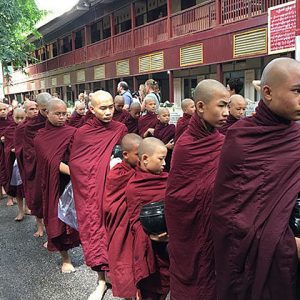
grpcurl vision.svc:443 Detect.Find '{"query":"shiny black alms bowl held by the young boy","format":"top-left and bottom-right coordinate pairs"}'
top-left (140, 201), bottom-right (167, 234)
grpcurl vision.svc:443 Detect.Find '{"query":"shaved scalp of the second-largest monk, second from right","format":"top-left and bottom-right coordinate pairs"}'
top-left (194, 79), bottom-right (227, 104)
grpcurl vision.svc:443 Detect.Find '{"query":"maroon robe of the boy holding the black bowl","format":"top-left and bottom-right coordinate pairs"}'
top-left (126, 168), bottom-right (169, 299)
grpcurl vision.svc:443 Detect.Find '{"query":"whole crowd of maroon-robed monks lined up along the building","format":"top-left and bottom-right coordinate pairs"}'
top-left (0, 58), bottom-right (300, 300)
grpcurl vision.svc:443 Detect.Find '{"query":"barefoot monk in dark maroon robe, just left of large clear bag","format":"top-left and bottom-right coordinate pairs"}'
top-left (34, 99), bottom-right (80, 273)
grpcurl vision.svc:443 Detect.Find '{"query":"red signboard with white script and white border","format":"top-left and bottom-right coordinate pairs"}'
top-left (268, 1), bottom-right (296, 54)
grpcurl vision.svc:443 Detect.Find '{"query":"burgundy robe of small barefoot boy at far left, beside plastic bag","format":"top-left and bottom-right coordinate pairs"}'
top-left (4, 122), bottom-right (24, 198)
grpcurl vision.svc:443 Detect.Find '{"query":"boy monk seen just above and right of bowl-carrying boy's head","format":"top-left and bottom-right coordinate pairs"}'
top-left (153, 107), bottom-right (175, 172)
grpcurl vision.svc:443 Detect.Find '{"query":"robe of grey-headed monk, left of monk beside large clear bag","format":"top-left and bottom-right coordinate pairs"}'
top-left (23, 113), bottom-right (46, 218)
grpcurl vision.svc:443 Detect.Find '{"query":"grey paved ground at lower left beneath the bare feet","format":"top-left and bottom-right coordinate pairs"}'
top-left (0, 199), bottom-right (122, 300)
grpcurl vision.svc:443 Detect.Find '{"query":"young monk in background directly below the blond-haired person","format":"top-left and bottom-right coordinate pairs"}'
top-left (138, 96), bottom-right (158, 138)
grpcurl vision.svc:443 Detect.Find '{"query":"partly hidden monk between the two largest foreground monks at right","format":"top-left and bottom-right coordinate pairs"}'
top-left (219, 94), bottom-right (247, 135)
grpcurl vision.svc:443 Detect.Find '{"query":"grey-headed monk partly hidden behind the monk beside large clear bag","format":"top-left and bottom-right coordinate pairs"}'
top-left (23, 93), bottom-right (52, 237)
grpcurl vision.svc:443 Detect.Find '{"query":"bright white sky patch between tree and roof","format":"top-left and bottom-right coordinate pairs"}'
top-left (35, 0), bottom-right (78, 28)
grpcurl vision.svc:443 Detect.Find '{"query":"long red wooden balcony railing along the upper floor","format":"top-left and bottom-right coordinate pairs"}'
top-left (27, 0), bottom-right (291, 75)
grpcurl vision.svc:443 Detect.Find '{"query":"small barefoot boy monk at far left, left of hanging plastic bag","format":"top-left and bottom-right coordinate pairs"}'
top-left (4, 108), bottom-right (25, 213)
